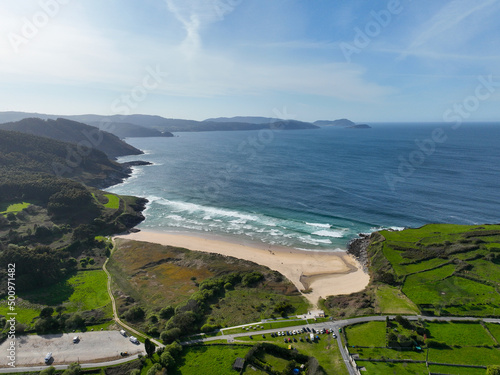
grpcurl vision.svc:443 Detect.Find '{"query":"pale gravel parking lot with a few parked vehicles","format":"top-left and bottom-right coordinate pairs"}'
top-left (0, 331), bottom-right (145, 367)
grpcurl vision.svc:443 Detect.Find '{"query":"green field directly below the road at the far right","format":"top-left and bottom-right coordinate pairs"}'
top-left (425, 322), bottom-right (496, 346)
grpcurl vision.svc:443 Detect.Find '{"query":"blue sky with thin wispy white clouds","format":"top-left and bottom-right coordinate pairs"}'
top-left (0, 0), bottom-right (500, 122)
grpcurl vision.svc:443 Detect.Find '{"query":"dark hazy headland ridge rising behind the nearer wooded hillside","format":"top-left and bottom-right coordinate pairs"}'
top-left (0, 118), bottom-right (142, 158)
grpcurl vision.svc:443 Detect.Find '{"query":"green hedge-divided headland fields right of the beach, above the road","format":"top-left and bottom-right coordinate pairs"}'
top-left (368, 224), bottom-right (500, 317)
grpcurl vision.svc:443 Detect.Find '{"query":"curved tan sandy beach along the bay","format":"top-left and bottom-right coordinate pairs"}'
top-left (117, 231), bottom-right (370, 307)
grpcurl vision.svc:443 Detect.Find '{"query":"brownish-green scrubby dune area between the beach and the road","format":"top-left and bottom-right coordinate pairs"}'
top-left (107, 240), bottom-right (307, 342)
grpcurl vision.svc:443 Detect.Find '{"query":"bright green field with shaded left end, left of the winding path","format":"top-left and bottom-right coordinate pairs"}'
top-left (20, 270), bottom-right (111, 312)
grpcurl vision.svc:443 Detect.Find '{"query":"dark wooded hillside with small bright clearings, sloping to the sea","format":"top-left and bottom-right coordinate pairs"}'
top-left (0, 130), bottom-right (146, 296)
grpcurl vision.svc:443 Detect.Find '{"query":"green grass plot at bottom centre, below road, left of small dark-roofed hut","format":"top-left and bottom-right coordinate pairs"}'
top-left (172, 345), bottom-right (250, 375)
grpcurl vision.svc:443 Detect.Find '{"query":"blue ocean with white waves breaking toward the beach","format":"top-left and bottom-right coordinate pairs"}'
top-left (107, 123), bottom-right (500, 250)
